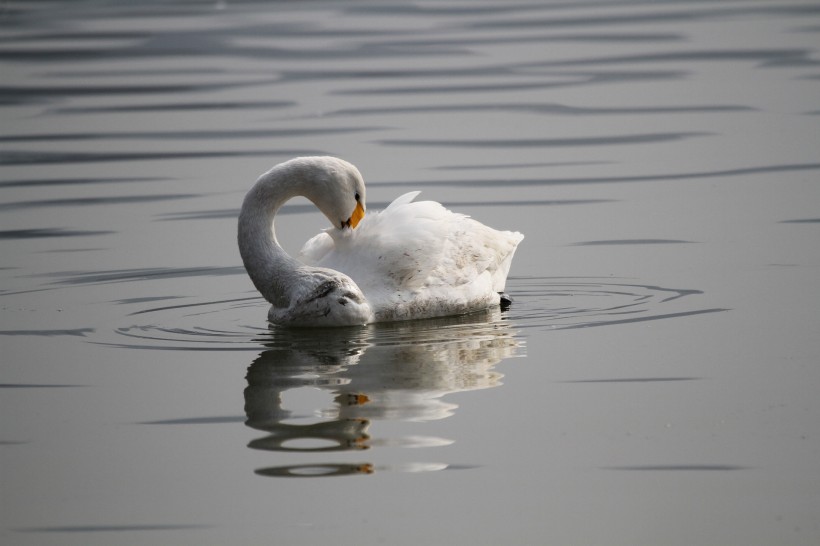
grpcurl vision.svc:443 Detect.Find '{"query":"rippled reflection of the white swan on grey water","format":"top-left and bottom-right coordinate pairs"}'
top-left (245, 310), bottom-right (520, 477)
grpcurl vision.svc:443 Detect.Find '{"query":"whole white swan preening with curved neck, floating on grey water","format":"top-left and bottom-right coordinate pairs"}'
top-left (237, 157), bottom-right (524, 326)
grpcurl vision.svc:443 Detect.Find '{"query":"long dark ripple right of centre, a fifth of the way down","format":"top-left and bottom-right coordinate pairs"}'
top-left (322, 102), bottom-right (755, 117)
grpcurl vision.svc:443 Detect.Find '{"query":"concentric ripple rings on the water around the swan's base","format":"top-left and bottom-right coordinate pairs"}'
top-left (107, 277), bottom-right (726, 351)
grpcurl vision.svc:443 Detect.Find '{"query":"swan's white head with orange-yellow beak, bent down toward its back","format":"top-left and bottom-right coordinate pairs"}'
top-left (288, 157), bottom-right (365, 229)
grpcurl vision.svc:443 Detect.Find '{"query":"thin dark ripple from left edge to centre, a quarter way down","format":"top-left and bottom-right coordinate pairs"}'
top-left (0, 127), bottom-right (384, 143)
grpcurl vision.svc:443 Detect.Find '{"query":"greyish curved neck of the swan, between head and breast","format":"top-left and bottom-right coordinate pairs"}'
top-left (238, 172), bottom-right (305, 307)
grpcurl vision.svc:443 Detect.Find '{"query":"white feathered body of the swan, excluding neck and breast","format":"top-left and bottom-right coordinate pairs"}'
top-left (300, 192), bottom-right (524, 321)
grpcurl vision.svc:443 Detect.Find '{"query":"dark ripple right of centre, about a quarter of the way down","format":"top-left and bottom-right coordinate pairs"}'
top-left (376, 133), bottom-right (712, 148)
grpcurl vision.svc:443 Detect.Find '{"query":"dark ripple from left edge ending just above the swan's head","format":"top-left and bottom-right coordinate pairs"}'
top-left (0, 149), bottom-right (327, 166)
